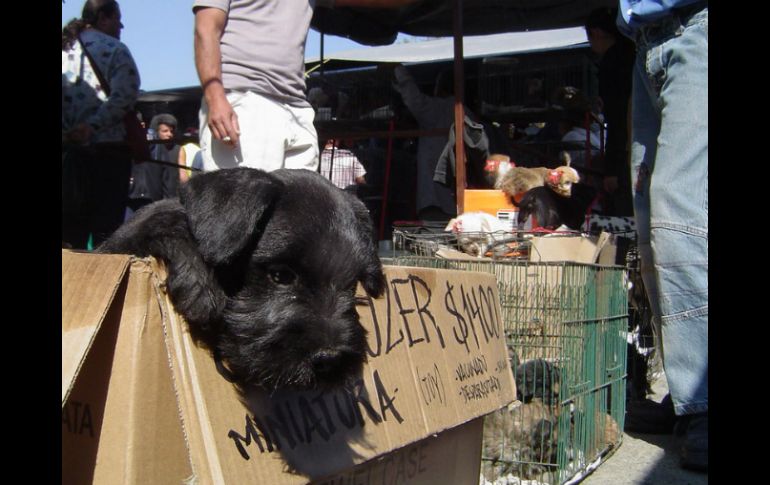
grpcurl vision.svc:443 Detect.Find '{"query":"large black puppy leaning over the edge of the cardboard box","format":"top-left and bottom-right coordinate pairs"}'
top-left (97, 168), bottom-right (385, 389)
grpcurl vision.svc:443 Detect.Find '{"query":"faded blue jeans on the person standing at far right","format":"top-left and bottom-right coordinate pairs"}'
top-left (631, 8), bottom-right (708, 415)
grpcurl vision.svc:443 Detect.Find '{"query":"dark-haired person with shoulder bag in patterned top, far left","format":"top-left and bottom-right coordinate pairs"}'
top-left (62, 0), bottom-right (142, 249)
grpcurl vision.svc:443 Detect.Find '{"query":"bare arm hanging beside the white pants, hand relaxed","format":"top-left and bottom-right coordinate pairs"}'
top-left (195, 7), bottom-right (240, 146)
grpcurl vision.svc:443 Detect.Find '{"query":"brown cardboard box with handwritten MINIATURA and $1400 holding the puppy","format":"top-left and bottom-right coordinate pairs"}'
top-left (62, 251), bottom-right (516, 484)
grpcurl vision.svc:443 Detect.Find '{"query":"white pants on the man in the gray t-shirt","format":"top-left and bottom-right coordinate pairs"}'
top-left (200, 91), bottom-right (318, 172)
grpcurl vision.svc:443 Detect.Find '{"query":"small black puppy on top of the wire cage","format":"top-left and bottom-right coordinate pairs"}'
top-left (512, 184), bottom-right (596, 230)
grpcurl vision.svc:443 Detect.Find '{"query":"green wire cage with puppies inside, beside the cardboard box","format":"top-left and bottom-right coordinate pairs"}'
top-left (389, 229), bottom-right (628, 485)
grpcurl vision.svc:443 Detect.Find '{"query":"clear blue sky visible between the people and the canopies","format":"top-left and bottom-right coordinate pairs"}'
top-left (62, 0), bottom-right (402, 91)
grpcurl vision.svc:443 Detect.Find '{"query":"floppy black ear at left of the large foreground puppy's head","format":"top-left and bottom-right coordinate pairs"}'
top-left (179, 168), bottom-right (283, 265)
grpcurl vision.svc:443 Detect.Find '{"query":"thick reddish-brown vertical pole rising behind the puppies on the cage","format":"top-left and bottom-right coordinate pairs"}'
top-left (452, 0), bottom-right (465, 215)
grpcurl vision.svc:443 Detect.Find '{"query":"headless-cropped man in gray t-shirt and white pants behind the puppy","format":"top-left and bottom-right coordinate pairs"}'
top-left (193, 0), bottom-right (415, 171)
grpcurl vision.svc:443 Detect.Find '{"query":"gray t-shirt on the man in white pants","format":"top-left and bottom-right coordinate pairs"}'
top-left (193, 0), bottom-right (330, 107)
